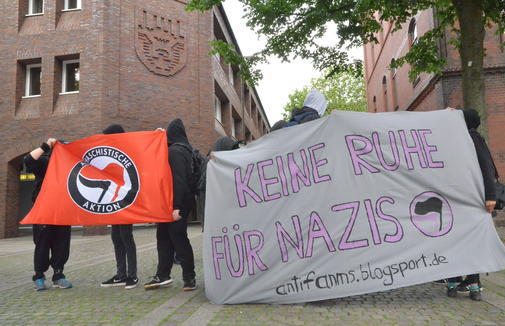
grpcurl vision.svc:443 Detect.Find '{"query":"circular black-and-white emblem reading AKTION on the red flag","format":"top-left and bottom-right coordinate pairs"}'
top-left (67, 146), bottom-right (140, 214)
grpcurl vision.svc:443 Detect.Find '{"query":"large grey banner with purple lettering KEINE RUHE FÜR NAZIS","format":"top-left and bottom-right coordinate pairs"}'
top-left (204, 110), bottom-right (505, 304)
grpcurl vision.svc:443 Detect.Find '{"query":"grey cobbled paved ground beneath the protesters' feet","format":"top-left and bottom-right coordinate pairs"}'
top-left (0, 226), bottom-right (505, 326)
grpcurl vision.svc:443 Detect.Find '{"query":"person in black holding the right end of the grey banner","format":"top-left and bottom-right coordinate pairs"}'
top-left (447, 109), bottom-right (498, 301)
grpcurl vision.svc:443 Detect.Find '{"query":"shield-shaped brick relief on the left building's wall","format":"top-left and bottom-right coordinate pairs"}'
top-left (135, 8), bottom-right (187, 76)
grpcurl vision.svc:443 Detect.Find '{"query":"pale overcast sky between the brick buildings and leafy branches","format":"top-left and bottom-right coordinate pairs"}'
top-left (223, 0), bottom-right (363, 125)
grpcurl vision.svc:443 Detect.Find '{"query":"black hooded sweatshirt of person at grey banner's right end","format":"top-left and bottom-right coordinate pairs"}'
top-left (463, 109), bottom-right (498, 201)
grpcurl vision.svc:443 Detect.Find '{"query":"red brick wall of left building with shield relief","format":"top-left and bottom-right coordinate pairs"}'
top-left (0, 0), bottom-right (272, 238)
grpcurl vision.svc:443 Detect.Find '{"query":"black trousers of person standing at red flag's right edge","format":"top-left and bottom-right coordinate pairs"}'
top-left (156, 216), bottom-right (196, 280)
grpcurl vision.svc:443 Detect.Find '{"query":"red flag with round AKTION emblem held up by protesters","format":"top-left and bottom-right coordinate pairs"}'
top-left (21, 131), bottom-right (173, 225)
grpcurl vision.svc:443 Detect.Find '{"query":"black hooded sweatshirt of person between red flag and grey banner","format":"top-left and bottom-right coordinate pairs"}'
top-left (167, 119), bottom-right (194, 217)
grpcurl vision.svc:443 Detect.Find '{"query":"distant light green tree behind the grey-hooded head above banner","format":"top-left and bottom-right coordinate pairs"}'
top-left (283, 71), bottom-right (366, 120)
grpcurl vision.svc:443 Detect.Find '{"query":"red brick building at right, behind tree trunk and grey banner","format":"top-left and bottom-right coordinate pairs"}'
top-left (364, 9), bottom-right (505, 199)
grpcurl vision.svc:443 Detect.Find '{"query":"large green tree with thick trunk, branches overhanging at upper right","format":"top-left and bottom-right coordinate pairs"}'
top-left (187, 0), bottom-right (505, 132)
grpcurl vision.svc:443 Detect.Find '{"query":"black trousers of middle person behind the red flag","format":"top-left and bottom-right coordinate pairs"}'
top-left (111, 224), bottom-right (137, 279)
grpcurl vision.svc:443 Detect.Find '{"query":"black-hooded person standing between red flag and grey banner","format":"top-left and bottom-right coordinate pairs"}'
top-left (144, 119), bottom-right (196, 291)
